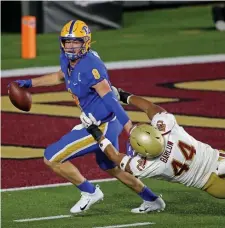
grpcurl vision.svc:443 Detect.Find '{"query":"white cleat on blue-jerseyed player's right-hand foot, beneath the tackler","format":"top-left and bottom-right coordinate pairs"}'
top-left (131, 196), bottom-right (166, 213)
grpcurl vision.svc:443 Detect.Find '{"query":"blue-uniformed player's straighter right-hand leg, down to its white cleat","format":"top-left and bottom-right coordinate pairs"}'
top-left (96, 120), bottom-right (166, 213)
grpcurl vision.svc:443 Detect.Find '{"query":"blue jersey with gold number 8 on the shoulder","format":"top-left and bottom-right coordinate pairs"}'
top-left (60, 51), bottom-right (112, 120)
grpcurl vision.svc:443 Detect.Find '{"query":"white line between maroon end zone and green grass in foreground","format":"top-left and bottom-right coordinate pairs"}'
top-left (1, 178), bottom-right (117, 192)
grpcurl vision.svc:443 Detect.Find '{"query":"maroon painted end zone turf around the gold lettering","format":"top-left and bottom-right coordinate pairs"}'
top-left (2, 62), bottom-right (225, 188)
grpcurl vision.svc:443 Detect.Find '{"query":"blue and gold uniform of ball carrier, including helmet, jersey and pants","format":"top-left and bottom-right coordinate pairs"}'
top-left (44, 21), bottom-right (129, 170)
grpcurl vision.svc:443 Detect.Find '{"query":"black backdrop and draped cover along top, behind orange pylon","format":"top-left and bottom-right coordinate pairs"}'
top-left (1, 1), bottom-right (212, 33)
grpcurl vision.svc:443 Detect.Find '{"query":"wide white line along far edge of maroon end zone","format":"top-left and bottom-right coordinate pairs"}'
top-left (1, 54), bottom-right (225, 77)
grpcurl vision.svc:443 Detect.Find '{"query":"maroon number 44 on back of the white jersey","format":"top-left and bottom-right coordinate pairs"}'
top-left (171, 141), bottom-right (196, 176)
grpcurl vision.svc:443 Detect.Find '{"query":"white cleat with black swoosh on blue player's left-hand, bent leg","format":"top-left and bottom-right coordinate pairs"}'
top-left (70, 185), bottom-right (104, 214)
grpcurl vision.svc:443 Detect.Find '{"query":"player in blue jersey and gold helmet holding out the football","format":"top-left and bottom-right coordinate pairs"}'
top-left (9, 20), bottom-right (165, 213)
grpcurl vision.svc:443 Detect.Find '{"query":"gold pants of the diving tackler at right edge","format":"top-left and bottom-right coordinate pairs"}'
top-left (203, 173), bottom-right (225, 199)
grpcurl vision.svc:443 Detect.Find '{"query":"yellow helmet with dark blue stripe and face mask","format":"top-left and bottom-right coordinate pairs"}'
top-left (60, 20), bottom-right (91, 60)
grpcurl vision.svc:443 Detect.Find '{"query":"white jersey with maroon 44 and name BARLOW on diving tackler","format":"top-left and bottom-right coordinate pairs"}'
top-left (130, 112), bottom-right (219, 188)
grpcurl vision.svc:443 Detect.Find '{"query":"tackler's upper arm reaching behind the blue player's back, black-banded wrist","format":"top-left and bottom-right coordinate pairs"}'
top-left (113, 87), bottom-right (166, 120)
